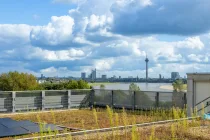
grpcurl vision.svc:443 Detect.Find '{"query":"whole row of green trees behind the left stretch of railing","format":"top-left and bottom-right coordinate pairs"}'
top-left (0, 71), bottom-right (91, 91)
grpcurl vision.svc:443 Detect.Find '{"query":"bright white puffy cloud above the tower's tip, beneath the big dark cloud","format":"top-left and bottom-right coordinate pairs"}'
top-left (136, 36), bottom-right (205, 63)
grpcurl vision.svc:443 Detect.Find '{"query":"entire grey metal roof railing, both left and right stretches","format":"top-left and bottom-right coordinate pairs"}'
top-left (0, 90), bottom-right (186, 112)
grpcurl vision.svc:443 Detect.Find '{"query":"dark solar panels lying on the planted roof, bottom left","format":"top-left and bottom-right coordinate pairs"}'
top-left (0, 118), bottom-right (63, 137)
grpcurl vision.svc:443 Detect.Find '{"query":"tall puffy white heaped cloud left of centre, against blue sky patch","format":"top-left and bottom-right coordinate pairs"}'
top-left (30, 16), bottom-right (74, 45)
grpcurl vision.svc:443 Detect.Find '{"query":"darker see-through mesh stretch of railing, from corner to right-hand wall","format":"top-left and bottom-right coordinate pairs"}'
top-left (92, 90), bottom-right (187, 109)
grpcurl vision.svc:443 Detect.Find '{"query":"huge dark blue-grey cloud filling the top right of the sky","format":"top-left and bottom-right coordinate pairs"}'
top-left (111, 0), bottom-right (210, 35)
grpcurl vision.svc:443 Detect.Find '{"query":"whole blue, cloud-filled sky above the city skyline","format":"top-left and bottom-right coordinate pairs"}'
top-left (0, 0), bottom-right (210, 78)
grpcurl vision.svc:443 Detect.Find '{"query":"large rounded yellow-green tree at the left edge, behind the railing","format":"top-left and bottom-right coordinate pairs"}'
top-left (0, 71), bottom-right (39, 91)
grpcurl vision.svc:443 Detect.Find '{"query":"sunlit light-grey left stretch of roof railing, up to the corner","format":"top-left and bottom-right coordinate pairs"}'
top-left (0, 90), bottom-right (92, 112)
